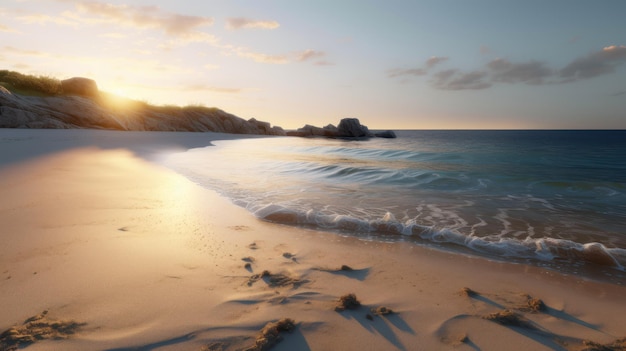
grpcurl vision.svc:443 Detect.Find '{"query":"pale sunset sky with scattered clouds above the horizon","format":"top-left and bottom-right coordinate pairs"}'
top-left (0, 0), bottom-right (626, 129)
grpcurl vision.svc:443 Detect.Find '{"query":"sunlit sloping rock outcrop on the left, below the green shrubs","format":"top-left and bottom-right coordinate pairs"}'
top-left (0, 88), bottom-right (285, 135)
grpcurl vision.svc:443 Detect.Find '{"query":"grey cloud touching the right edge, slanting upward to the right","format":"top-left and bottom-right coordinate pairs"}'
top-left (560, 45), bottom-right (626, 82)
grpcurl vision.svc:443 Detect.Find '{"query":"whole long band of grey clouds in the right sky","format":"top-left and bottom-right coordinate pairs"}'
top-left (387, 45), bottom-right (626, 90)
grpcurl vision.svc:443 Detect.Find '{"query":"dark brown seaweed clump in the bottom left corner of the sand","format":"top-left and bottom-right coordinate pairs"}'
top-left (0, 311), bottom-right (86, 351)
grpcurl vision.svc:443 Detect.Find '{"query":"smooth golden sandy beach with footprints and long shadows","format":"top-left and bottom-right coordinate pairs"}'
top-left (0, 130), bottom-right (626, 351)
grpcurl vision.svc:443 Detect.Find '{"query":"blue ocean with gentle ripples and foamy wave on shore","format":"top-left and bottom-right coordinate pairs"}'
top-left (163, 130), bottom-right (626, 285)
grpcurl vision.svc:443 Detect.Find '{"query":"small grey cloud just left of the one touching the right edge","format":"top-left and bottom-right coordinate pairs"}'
top-left (487, 58), bottom-right (554, 85)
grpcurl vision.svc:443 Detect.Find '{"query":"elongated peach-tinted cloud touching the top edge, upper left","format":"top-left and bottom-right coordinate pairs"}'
top-left (76, 1), bottom-right (214, 36)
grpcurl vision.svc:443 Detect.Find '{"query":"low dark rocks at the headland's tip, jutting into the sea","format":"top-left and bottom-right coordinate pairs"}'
top-left (287, 118), bottom-right (396, 139)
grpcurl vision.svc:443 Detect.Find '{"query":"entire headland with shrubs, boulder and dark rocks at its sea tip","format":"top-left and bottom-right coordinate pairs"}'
top-left (0, 70), bottom-right (396, 139)
